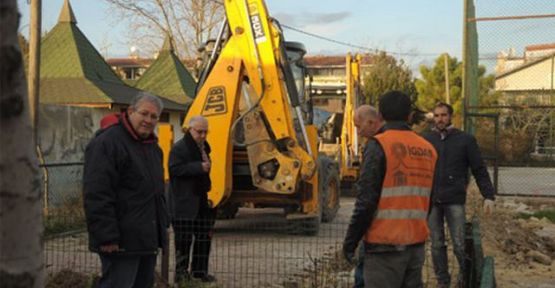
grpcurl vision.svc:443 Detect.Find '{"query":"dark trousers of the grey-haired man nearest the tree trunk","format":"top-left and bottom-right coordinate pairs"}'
top-left (98, 254), bottom-right (156, 288)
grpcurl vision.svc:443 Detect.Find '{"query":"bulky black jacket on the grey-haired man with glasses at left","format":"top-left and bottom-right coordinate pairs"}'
top-left (83, 115), bottom-right (169, 253)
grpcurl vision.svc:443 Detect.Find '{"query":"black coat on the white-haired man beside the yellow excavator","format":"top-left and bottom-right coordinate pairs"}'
top-left (169, 132), bottom-right (211, 219)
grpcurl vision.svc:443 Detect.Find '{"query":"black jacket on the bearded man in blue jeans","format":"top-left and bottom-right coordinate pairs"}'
top-left (424, 128), bottom-right (495, 204)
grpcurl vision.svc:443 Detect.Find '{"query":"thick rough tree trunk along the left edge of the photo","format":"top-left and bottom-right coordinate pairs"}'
top-left (0, 0), bottom-right (44, 287)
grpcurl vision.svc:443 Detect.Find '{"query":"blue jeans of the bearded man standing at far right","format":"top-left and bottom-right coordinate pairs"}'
top-left (428, 204), bottom-right (466, 285)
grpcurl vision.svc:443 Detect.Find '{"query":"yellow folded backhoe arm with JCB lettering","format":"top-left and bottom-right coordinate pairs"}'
top-left (184, 0), bottom-right (316, 206)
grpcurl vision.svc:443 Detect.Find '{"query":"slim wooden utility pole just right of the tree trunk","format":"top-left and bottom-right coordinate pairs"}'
top-left (27, 0), bottom-right (42, 146)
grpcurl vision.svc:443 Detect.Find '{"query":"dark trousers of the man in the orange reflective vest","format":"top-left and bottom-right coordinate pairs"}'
top-left (364, 244), bottom-right (424, 288)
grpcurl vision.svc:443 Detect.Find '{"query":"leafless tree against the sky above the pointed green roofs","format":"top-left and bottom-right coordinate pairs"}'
top-left (105, 0), bottom-right (224, 58)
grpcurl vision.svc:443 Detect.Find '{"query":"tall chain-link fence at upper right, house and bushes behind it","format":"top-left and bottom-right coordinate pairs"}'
top-left (464, 0), bottom-right (555, 197)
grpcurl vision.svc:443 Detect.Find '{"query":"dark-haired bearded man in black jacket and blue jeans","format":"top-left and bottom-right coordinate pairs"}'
top-left (424, 102), bottom-right (495, 287)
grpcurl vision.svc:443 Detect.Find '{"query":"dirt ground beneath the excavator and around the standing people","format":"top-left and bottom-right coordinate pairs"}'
top-left (45, 190), bottom-right (555, 288)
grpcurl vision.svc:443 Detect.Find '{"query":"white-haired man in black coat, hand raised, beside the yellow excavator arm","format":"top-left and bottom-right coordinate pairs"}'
top-left (169, 116), bottom-right (216, 282)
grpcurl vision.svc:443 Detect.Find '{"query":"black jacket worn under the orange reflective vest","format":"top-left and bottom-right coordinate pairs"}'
top-left (343, 122), bottom-right (411, 254)
